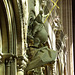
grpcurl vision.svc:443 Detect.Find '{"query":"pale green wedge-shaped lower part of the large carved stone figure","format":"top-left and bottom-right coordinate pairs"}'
top-left (26, 46), bottom-right (58, 70)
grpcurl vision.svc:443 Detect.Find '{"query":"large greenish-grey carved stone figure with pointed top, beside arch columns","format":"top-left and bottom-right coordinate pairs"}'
top-left (26, 11), bottom-right (57, 70)
